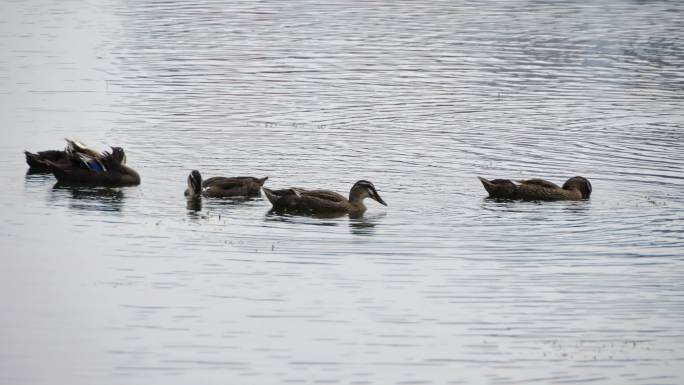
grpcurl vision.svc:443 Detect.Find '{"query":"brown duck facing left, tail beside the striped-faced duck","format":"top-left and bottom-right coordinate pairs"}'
top-left (185, 170), bottom-right (268, 198)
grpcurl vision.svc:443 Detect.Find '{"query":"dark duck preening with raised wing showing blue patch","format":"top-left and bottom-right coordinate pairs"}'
top-left (45, 147), bottom-right (140, 187)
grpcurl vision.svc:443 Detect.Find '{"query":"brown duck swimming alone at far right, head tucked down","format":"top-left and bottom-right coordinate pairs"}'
top-left (478, 176), bottom-right (591, 201)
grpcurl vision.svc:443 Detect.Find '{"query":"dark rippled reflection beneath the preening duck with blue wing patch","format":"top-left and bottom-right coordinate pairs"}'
top-left (49, 183), bottom-right (126, 212)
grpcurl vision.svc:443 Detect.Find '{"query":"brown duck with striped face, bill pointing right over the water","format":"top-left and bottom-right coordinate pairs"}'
top-left (263, 180), bottom-right (387, 215)
